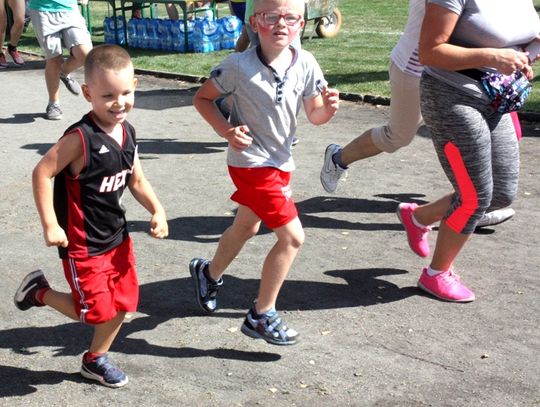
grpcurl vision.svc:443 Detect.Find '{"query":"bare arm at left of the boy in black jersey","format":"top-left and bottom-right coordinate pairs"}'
top-left (32, 133), bottom-right (83, 247)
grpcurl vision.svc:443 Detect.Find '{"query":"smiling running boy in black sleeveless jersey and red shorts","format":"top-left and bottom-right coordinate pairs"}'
top-left (14, 45), bottom-right (168, 387)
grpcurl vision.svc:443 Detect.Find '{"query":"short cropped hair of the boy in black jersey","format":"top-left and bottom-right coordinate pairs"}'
top-left (84, 44), bottom-right (133, 82)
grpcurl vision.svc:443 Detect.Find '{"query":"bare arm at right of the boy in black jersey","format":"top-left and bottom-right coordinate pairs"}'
top-left (129, 156), bottom-right (169, 239)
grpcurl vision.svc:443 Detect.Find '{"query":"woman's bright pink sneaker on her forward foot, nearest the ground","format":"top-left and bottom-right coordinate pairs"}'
top-left (418, 267), bottom-right (475, 302)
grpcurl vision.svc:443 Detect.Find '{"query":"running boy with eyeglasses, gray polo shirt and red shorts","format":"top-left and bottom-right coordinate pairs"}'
top-left (189, 0), bottom-right (339, 345)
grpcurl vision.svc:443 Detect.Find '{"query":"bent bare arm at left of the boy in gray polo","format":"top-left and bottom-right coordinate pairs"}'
top-left (193, 80), bottom-right (253, 151)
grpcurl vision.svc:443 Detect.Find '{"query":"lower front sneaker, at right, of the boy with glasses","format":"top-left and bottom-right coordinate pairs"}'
top-left (240, 307), bottom-right (300, 345)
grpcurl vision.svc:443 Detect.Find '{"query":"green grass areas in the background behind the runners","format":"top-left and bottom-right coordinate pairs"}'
top-left (20, 0), bottom-right (540, 112)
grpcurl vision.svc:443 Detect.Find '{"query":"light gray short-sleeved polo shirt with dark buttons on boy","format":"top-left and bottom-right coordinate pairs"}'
top-left (211, 47), bottom-right (325, 172)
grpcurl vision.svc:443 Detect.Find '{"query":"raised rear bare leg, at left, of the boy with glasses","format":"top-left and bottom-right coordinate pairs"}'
top-left (208, 205), bottom-right (261, 281)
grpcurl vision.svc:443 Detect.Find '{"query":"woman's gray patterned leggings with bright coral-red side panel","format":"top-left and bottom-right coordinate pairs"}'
top-left (420, 73), bottom-right (519, 234)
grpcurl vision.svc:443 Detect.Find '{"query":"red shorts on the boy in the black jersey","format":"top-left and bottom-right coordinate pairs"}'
top-left (62, 237), bottom-right (139, 325)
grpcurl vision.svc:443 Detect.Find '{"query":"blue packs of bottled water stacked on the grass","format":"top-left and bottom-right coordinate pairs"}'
top-left (122, 16), bottom-right (242, 53)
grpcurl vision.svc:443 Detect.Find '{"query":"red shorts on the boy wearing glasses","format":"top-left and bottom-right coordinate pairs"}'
top-left (229, 166), bottom-right (298, 229)
